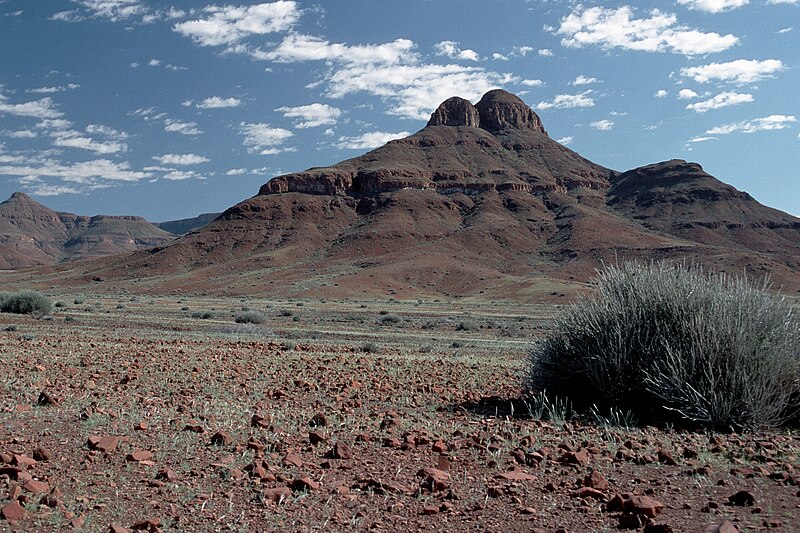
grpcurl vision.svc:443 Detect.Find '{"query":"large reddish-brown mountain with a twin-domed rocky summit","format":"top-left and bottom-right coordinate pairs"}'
top-left (7, 90), bottom-right (800, 299)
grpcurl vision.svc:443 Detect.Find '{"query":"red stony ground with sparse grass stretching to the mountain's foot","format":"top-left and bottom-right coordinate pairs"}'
top-left (0, 293), bottom-right (800, 533)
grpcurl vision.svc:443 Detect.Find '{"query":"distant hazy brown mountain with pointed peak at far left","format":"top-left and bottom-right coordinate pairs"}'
top-left (0, 192), bottom-right (175, 269)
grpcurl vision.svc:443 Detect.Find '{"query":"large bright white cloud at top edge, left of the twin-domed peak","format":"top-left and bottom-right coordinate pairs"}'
top-left (173, 0), bottom-right (300, 46)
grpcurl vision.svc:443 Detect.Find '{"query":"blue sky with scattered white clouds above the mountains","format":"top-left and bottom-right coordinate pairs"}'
top-left (0, 0), bottom-right (800, 221)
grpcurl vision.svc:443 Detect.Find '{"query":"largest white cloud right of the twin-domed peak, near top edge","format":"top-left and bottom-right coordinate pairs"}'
top-left (555, 5), bottom-right (739, 56)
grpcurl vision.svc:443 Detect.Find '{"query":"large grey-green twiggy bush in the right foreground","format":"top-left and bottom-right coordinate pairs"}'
top-left (525, 263), bottom-right (800, 430)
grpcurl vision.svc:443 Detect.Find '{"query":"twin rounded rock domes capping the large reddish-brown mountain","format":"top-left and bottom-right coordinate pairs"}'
top-left (428, 89), bottom-right (547, 134)
